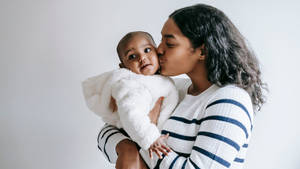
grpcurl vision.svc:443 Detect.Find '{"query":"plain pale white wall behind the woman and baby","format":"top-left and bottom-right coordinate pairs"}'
top-left (0, 0), bottom-right (300, 169)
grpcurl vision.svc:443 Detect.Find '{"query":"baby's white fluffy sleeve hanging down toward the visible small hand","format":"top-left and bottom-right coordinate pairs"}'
top-left (112, 79), bottom-right (160, 150)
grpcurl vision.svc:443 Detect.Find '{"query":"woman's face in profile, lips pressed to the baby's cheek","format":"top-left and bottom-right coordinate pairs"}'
top-left (157, 18), bottom-right (198, 76)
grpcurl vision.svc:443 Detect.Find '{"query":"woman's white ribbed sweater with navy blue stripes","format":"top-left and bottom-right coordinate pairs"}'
top-left (98, 79), bottom-right (253, 169)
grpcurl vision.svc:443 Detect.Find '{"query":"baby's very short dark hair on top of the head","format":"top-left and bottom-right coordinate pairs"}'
top-left (117, 31), bottom-right (156, 63)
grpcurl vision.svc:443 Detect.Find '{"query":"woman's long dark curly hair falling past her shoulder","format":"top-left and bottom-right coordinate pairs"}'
top-left (169, 4), bottom-right (267, 110)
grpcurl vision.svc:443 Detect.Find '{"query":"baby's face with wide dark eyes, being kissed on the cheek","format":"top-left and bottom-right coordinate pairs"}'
top-left (120, 34), bottom-right (159, 75)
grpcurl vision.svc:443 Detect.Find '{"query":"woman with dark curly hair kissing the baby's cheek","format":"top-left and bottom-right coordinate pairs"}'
top-left (98, 4), bottom-right (264, 168)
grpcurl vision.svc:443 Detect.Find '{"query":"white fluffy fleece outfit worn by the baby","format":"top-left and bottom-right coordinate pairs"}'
top-left (82, 68), bottom-right (178, 150)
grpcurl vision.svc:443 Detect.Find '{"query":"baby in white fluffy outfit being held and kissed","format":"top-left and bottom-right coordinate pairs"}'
top-left (82, 31), bottom-right (178, 158)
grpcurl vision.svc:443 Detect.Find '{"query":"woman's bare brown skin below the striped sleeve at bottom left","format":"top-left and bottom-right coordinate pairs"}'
top-left (116, 139), bottom-right (148, 169)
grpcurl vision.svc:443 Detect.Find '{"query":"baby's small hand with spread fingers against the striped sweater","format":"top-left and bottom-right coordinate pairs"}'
top-left (149, 134), bottom-right (171, 159)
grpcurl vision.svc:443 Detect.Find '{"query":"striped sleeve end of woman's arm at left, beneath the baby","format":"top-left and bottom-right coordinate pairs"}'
top-left (97, 124), bottom-right (130, 163)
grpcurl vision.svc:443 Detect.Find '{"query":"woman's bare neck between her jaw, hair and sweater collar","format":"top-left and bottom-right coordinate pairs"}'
top-left (187, 62), bottom-right (212, 96)
